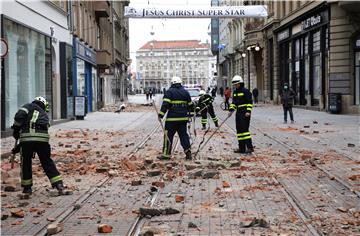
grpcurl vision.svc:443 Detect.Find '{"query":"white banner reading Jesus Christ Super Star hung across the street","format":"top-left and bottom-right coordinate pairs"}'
top-left (124, 5), bottom-right (268, 18)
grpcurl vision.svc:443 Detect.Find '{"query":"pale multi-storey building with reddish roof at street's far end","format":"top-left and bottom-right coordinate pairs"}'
top-left (136, 40), bottom-right (215, 91)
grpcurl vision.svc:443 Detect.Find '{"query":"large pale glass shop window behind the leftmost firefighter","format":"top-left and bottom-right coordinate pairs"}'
top-left (1, 15), bottom-right (53, 131)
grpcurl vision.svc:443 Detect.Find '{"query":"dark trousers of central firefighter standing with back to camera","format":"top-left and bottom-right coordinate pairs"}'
top-left (163, 121), bottom-right (190, 157)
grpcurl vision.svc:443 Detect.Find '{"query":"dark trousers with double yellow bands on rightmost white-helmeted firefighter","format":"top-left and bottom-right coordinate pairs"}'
top-left (235, 111), bottom-right (253, 152)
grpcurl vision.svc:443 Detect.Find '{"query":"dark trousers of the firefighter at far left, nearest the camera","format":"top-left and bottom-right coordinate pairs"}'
top-left (21, 142), bottom-right (62, 187)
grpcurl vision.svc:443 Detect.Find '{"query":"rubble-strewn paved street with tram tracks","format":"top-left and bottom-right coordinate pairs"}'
top-left (1, 94), bottom-right (360, 235)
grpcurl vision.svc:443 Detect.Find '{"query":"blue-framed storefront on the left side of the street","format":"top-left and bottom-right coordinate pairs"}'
top-left (73, 38), bottom-right (98, 112)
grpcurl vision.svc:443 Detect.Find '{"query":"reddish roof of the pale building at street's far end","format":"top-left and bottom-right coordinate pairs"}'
top-left (139, 40), bottom-right (210, 50)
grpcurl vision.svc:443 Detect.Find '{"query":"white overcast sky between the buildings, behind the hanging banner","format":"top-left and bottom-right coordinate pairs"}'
top-left (129, 0), bottom-right (211, 71)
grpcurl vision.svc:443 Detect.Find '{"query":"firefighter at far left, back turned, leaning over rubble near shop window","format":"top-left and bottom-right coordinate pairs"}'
top-left (12, 97), bottom-right (64, 194)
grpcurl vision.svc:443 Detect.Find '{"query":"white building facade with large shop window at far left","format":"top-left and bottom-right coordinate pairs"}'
top-left (0, 1), bottom-right (73, 134)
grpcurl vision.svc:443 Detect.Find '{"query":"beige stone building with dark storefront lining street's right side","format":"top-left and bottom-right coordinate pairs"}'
top-left (227, 1), bottom-right (360, 113)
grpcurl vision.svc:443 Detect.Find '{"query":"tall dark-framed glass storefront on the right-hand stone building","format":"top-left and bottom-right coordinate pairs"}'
top-left (276, 9), bottom-right (329, 109)
